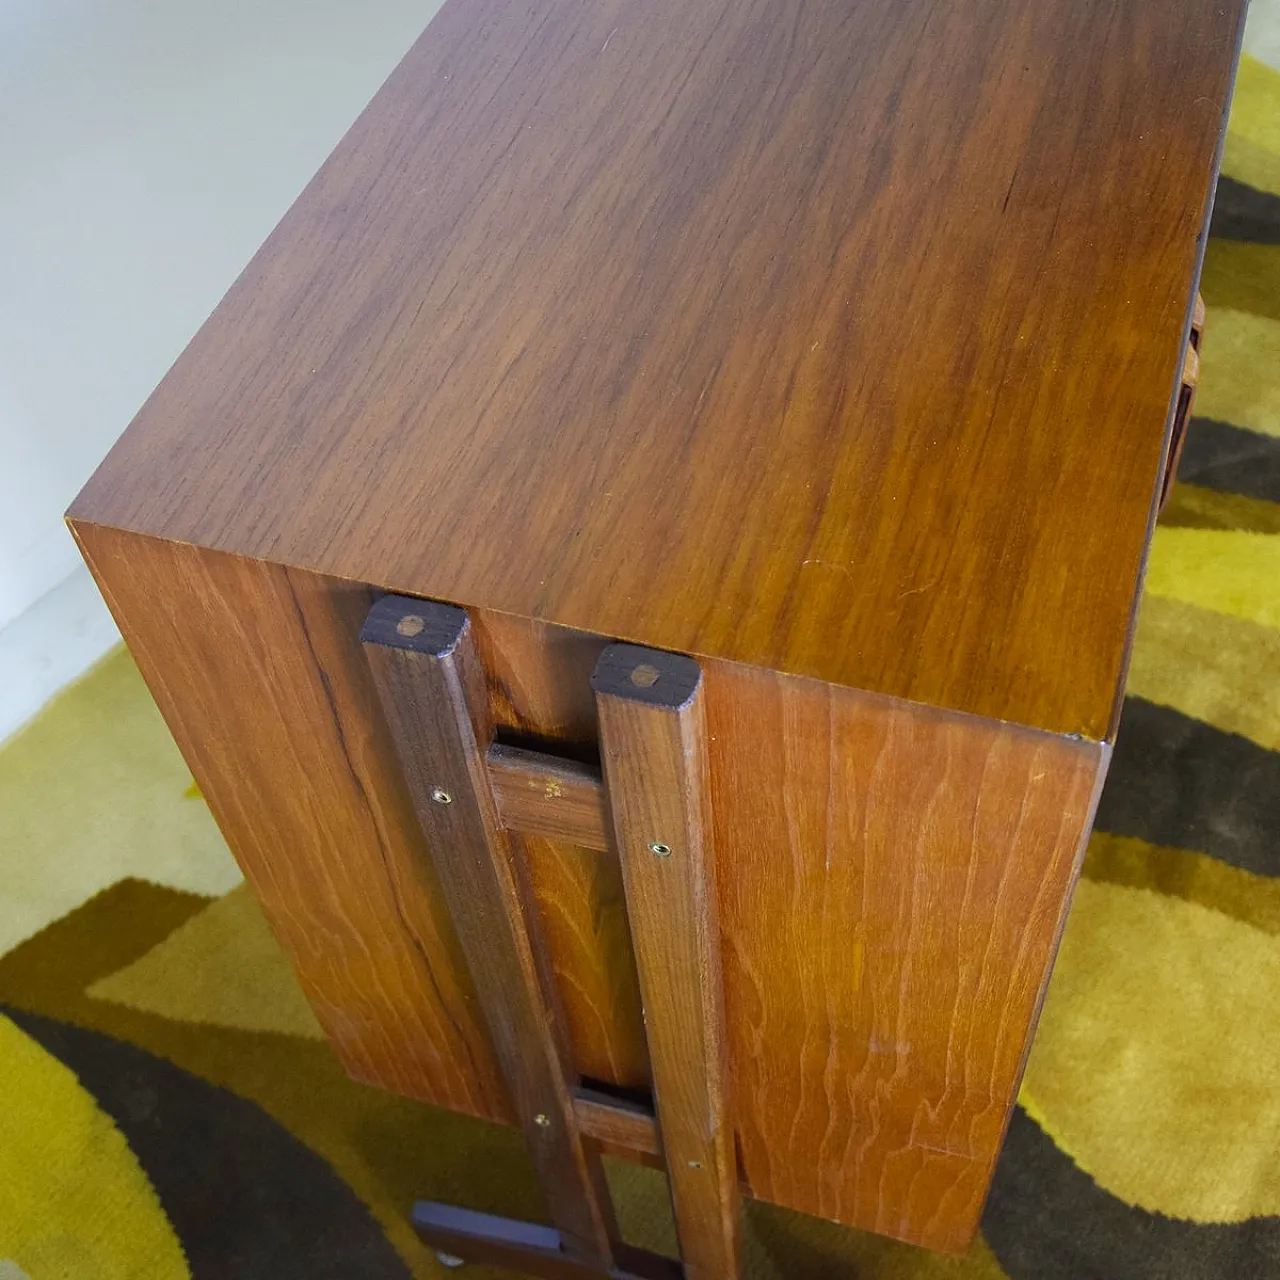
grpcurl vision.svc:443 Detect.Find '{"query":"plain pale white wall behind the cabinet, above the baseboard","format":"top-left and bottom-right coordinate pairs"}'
top-left (0, 0), bottom-right (438, 629)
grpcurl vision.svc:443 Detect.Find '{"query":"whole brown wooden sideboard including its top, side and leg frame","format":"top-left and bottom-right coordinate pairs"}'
top-left (69, 0), bottom-right (1243, 1277)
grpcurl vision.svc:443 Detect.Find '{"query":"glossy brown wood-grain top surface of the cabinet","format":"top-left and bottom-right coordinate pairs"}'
top-left (72, 0), bottom-right (1243, 737)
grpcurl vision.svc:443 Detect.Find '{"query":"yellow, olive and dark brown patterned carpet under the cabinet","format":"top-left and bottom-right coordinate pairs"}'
top-left (0, 49), bottom-right (1280, 1280)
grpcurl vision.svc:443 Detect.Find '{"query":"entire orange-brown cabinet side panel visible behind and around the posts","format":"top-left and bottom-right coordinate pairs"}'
top-left (77, 526), bottom-right (1106, 1248)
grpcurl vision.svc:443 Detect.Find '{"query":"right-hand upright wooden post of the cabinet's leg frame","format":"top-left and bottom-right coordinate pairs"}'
top-left (591, 644), bottom-right (741, 1280)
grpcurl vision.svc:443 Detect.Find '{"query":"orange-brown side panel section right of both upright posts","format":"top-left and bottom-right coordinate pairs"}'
top-left (707, 663), bottom-right (1103, 1249)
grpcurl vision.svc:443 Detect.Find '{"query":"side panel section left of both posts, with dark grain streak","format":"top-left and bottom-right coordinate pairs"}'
top-left (74, 524), bottom-right (511, 1120)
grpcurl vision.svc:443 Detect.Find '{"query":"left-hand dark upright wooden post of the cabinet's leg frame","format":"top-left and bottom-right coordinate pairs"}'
top-left (361, 595), bottom-right (620, 1271)
